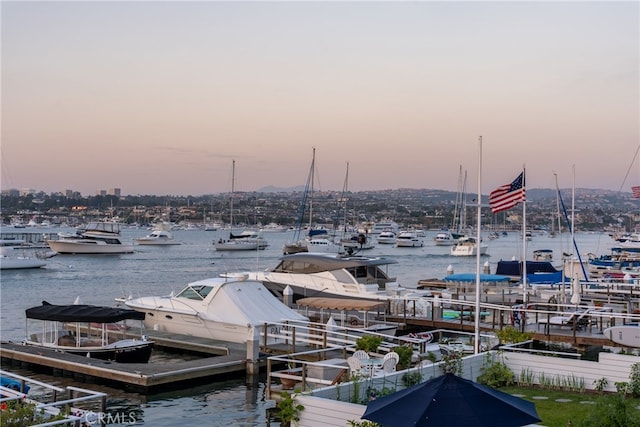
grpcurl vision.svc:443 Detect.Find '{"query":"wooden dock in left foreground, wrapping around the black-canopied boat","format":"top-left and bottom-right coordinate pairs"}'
top-left (0, 331), bottom-right (255, 393)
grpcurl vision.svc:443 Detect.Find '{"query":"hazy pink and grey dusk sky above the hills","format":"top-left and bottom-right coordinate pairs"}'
top-left (0, 1), bottom-right (640, 196)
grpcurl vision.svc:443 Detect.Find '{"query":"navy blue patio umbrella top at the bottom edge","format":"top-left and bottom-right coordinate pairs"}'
top-left (362, 374), bottom-right (541, 427)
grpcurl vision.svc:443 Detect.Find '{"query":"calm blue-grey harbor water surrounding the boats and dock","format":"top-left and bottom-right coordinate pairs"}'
top-left (0, 229), bottom-right (613, 427)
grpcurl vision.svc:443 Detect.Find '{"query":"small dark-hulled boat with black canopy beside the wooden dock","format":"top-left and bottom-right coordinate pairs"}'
top-left (24, 301), bottom-right (154, 363)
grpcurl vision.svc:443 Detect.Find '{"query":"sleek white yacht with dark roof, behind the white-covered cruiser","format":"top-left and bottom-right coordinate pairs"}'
top-left (248, 252), bottom-right (426, 300)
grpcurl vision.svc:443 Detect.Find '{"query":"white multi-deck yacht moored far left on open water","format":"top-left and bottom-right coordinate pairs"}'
top-left (46, 221), bottom-right (133, 254)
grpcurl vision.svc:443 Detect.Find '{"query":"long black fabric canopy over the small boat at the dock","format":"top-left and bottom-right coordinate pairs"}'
top-left (26, 301), bottom-right (144, 323)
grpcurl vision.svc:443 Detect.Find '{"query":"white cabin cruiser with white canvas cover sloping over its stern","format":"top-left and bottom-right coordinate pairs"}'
top-left (120, 274), bottom-right (307, 343)
